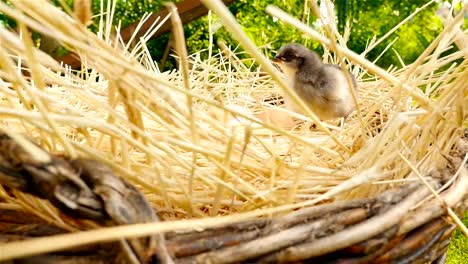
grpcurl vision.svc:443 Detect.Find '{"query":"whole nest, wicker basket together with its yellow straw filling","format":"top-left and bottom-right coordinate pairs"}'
top-left (0, 0), bottom-right (468, 263)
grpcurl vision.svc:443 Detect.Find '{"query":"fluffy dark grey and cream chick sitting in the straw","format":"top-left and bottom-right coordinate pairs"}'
top-left (272, 43), bottom-right (356, 120)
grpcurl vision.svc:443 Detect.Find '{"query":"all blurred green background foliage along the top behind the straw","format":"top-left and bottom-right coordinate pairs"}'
top-left (0, 0), bottom-right (467, 68)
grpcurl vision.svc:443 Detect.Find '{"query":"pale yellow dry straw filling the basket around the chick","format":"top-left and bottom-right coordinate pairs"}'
top-left (0, 0), bottom-right (468, 260)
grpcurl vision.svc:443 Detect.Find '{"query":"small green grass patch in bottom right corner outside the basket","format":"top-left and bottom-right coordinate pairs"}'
top-left (446, 212), bottom-right (468, 264)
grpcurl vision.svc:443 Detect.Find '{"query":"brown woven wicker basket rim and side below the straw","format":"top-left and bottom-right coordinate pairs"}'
top-left (0, 131), bottom-right (468, 263)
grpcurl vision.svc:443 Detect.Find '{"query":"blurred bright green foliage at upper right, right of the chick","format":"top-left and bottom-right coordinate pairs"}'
top-left (348, 0), bottom-right (443, 67)
